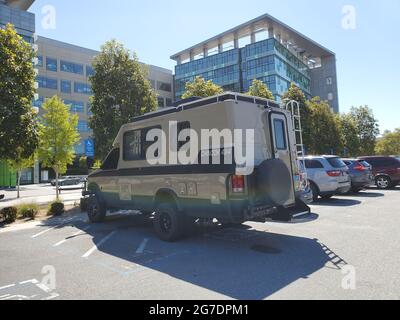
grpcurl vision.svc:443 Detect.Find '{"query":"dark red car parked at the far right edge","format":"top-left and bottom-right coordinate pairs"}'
top-left (359, 157), bottom-right (400, 190)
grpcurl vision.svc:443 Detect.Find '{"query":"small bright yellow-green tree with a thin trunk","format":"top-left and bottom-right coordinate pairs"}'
top-left (38, 96), bottom-right (80, 200)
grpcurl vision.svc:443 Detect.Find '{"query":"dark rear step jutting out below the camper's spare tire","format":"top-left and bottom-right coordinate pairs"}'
top-left (268, 199), bottom-right (314, 223)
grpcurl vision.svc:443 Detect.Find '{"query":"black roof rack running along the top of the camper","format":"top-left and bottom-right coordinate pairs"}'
top-left (133, 92), bottom-right (281, 122)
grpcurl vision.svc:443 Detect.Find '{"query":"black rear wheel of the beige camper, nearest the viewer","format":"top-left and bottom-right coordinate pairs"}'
top-left (154, 203), bottom-right (185, 242)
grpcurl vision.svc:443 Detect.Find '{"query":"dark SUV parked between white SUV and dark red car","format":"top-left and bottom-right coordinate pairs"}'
top-left (343, 159), bottom-right (375, 192)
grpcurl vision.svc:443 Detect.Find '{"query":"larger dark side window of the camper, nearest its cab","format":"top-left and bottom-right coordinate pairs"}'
top-left (124, 126), bottom-right (161, 161)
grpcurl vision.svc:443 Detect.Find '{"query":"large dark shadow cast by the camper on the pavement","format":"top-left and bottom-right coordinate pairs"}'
top-left (61, 212), bottom-right (338, 300)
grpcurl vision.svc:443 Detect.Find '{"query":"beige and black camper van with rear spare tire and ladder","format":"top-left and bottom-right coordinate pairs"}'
top-left (84, 93), bottom-right (310, 241)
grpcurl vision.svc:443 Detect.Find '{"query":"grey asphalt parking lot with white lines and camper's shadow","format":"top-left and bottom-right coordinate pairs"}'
top-left (0, 188), bottom-right (400, 300)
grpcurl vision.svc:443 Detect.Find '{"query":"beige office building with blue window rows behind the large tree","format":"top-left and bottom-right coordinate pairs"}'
top-left (34, 37), bottom-right (174, 156)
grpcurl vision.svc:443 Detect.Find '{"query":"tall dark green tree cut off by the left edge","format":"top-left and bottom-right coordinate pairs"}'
top-left (0, 24), bottom-right (38, 163)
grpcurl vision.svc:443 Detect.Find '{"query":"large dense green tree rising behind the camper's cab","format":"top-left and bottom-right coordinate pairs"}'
top-left (90, 40), bottom-right (157, 158)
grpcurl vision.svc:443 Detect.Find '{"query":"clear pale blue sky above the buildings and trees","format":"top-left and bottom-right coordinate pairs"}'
top-left (30, 0), bottom-right (400, 131)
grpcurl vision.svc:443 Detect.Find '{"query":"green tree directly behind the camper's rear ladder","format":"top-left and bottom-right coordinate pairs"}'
top-left (282, 83), bottom-right (312, 150)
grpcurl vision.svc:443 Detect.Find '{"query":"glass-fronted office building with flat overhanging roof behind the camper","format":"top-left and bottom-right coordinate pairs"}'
top-left (171, 14), bottom-right (339, 112)
